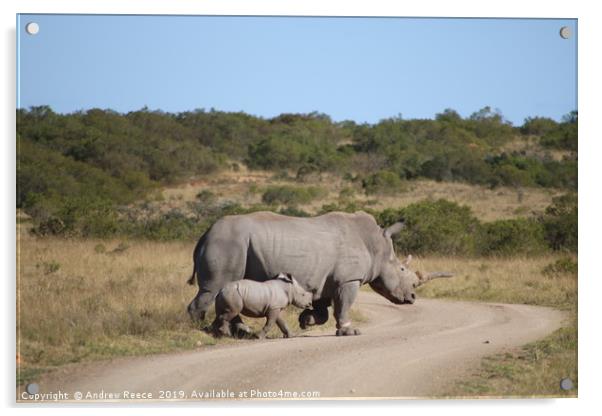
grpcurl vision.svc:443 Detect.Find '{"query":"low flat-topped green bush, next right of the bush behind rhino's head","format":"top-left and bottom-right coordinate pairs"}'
top-left (478, 218), bottom-right (548, 256)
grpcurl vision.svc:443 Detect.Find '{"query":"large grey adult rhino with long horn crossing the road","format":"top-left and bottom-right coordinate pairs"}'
top-left (188, 212), bottom-right (450, 335)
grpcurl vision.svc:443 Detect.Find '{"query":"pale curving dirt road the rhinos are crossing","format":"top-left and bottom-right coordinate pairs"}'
top-left (25, 292), bottom-right (563, 400)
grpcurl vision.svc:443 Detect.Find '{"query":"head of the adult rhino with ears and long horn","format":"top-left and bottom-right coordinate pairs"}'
top-left (369, 222), bottom-right (453, 305)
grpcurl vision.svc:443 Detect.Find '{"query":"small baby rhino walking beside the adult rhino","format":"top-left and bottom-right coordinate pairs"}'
top-left (211, 273), bottom-right (312, 338)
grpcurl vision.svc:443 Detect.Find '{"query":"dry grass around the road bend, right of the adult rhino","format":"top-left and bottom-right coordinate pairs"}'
top-left (414, 255), bottom-right (577, 397)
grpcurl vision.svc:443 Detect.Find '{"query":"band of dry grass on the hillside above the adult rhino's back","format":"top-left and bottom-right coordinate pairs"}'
top-left (160, 162), bottom-right (562, 221)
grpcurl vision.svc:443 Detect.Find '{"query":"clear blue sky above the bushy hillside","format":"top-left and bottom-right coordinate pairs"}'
top-left (17, 15), bottom-right (577, 125)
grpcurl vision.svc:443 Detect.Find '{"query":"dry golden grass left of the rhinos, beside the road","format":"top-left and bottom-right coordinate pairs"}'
top-left (17, 230), bottom-right (356, 383)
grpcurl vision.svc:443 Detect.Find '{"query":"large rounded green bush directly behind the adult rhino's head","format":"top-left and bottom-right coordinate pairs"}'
top-left (377, 199), bottom-right (479, 255)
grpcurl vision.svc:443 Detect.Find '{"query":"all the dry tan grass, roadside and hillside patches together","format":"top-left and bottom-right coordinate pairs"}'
top-left (17, 170), bottom-right (577, 396)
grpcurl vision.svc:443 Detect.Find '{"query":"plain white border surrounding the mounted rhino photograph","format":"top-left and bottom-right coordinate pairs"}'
top-left (0, 0), bottom-right (602, 416)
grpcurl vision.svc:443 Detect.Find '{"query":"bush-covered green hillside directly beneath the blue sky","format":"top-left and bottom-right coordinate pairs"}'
top-left (17, 107), bottom-right (577, 238)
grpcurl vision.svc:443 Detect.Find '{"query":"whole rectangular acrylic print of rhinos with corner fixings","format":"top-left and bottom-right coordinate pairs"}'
top-left (17, 15), bottom-right (578, 403)
